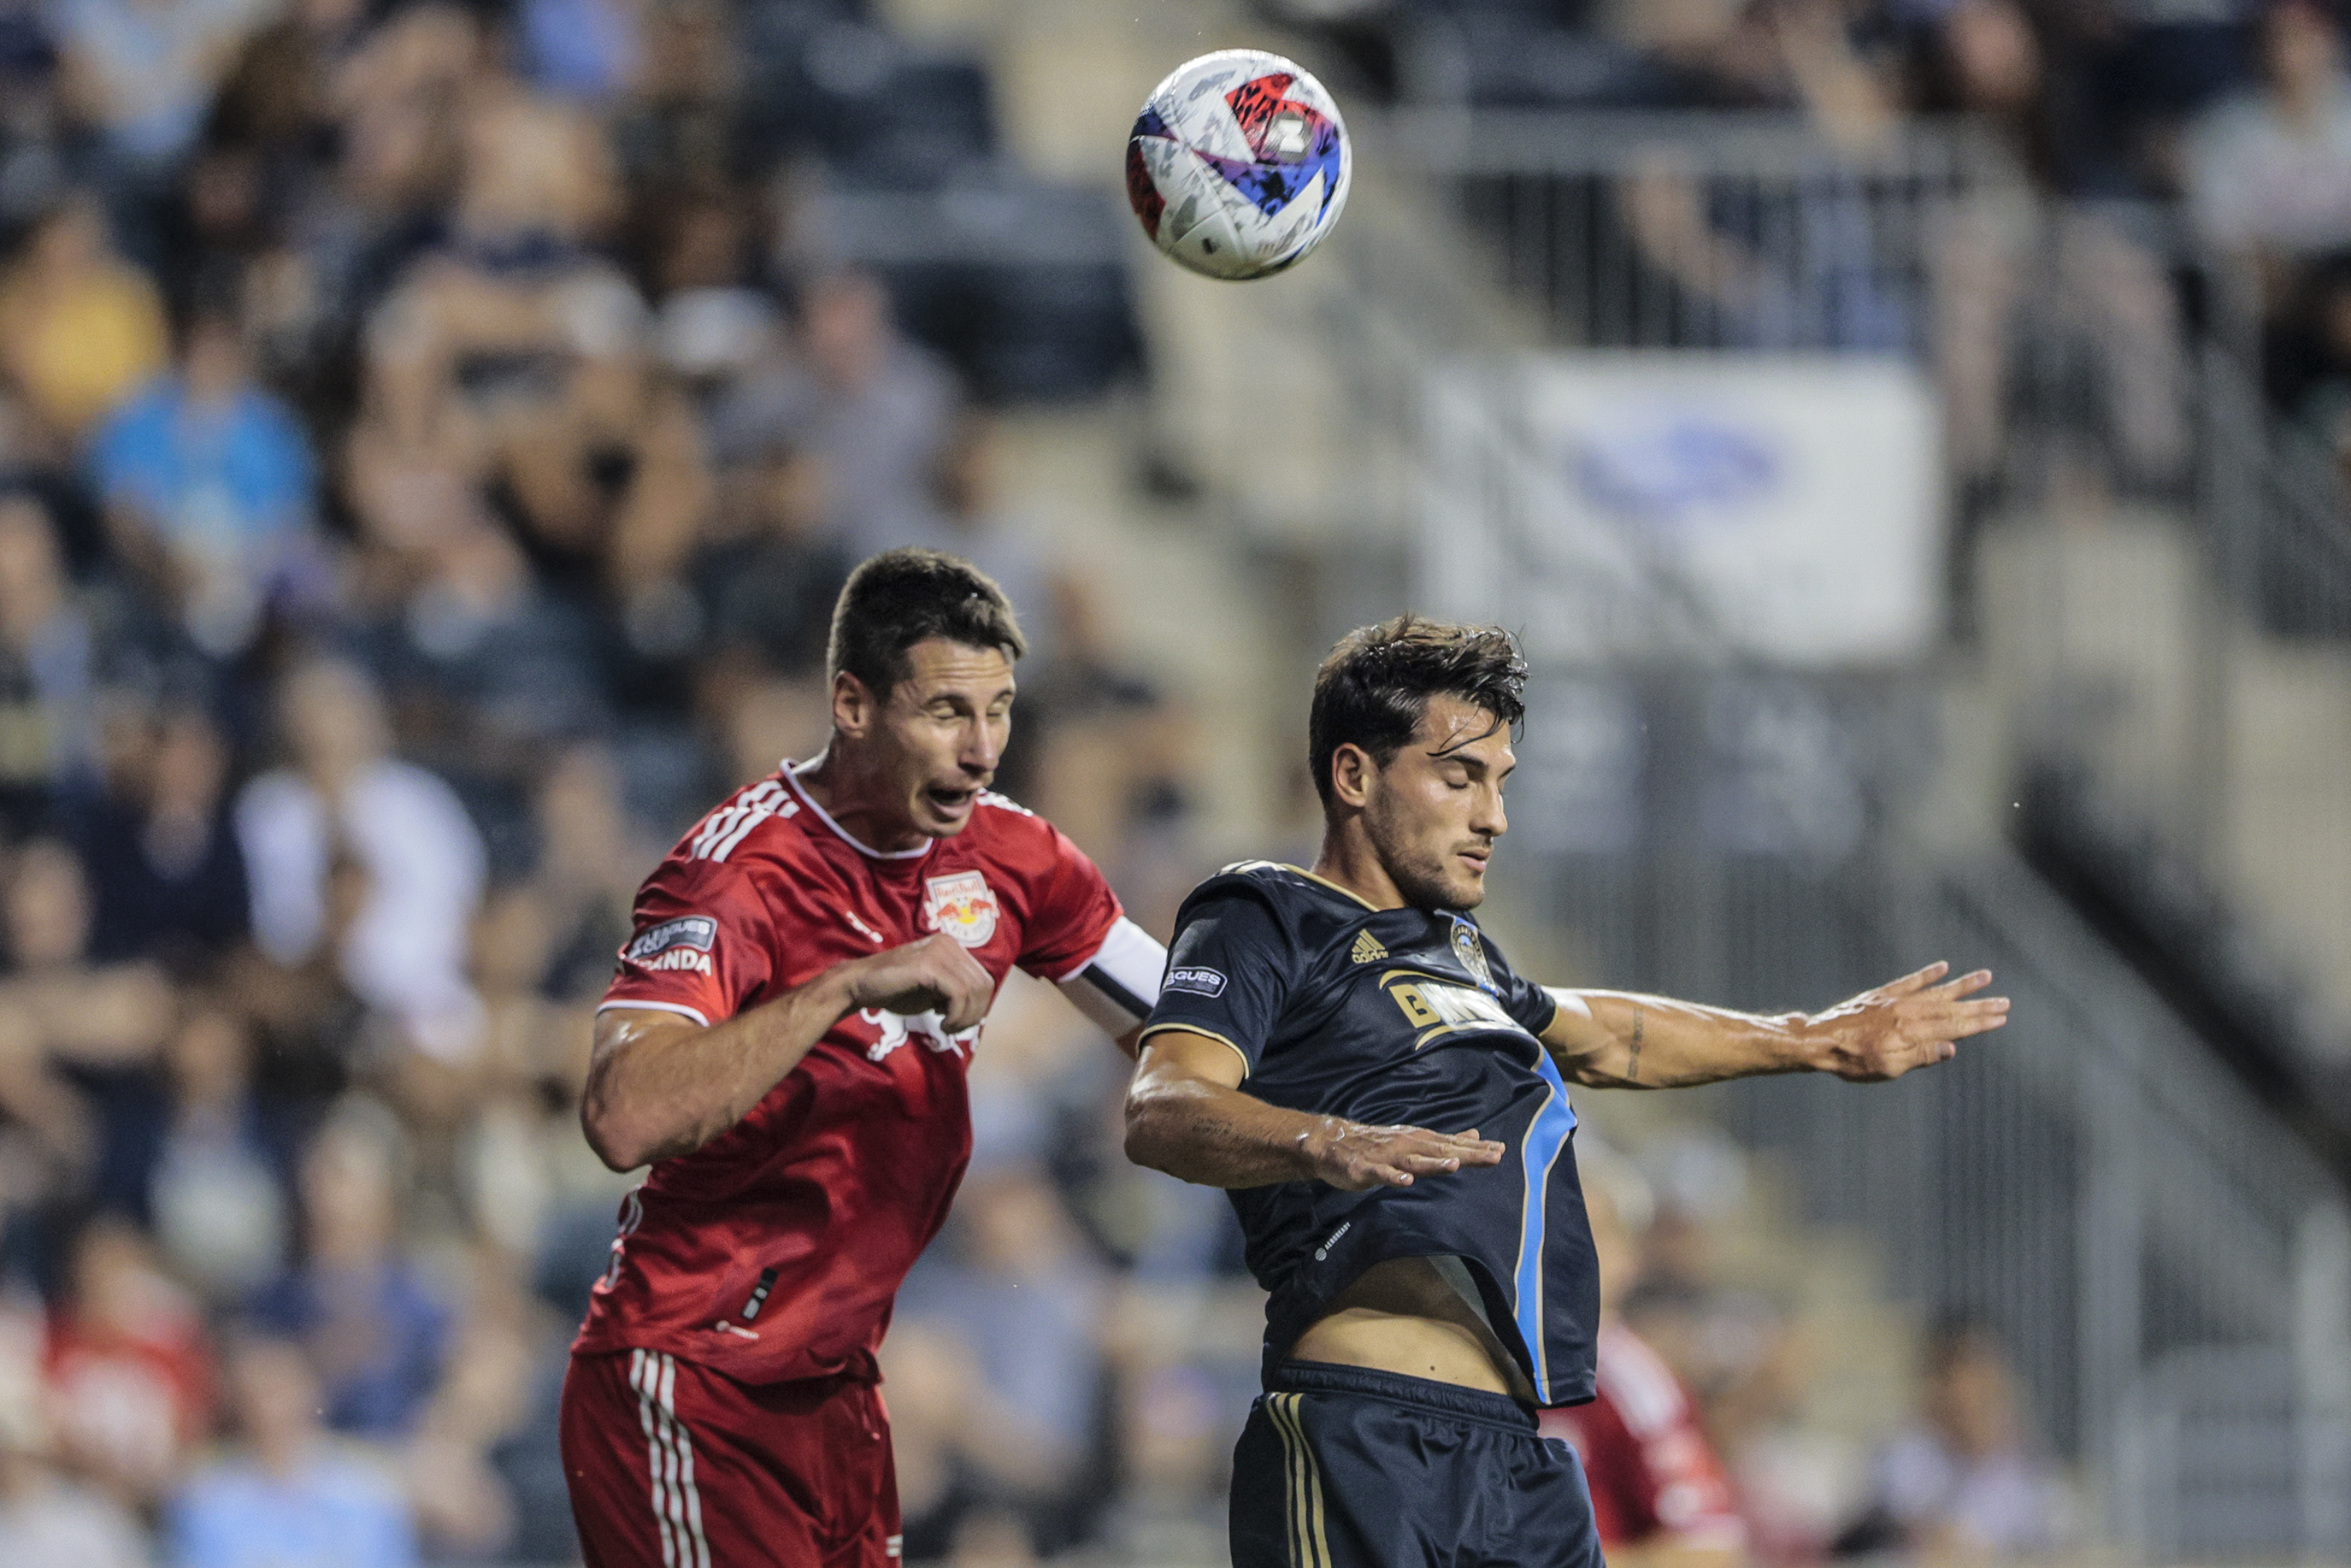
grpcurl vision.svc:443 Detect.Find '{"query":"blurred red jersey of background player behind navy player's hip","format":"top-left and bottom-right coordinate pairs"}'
top-left (1542, 1319), bottom-right (1747, 1549)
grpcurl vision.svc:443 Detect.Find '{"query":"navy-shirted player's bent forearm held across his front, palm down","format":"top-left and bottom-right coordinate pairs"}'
top-left (1126, 1029), bottom-right (1502, 1192)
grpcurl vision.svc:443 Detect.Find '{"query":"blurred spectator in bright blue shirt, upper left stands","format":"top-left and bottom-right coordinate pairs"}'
top-left (91, 315), bottom-right (317, 658)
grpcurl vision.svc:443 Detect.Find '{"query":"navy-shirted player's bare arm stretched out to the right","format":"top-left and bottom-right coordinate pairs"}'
top-left (1542, 964), bottom-right (2008, 1088)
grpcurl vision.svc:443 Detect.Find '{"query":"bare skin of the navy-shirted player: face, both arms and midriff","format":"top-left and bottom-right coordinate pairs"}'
top-left (1126, 696), bottom-right (2008, 1399)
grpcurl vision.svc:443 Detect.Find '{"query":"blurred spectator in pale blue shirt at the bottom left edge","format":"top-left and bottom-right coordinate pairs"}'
top-left (169, 1340), bottom-right (416, 1568)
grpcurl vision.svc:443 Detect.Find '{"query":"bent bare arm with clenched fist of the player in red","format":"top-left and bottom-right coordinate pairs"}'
top-left (580, 935), bottom-right (994, 1170)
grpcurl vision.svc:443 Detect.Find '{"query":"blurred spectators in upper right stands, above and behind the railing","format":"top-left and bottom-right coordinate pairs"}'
top-left (1288, 0), bottom-right (2351, 493)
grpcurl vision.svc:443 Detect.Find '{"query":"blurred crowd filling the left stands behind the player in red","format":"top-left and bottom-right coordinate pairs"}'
top-left (0, 0), bottom-right (1194, 1568)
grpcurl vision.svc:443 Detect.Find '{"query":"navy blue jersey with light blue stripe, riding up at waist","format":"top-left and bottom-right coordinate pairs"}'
top-left (1143, 860), bottom-right (1599, 1406)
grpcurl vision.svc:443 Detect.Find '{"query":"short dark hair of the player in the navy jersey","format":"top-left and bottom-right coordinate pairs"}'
top-left (1307, 614), bottom-right (1526, 811)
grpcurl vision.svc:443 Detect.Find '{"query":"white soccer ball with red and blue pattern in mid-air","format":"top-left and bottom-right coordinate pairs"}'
top-left (1126, 50), bottom-right (1354, 280)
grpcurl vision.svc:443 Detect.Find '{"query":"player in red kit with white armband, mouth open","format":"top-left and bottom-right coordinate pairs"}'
top-left (562, 550), bottom-right (1166, 1568)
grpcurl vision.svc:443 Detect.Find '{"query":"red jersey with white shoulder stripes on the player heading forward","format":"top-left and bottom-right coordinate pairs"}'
top-left (574, 764), bottom-right (1157, 1382)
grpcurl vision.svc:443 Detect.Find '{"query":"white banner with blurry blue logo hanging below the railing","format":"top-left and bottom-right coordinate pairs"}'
top-left (1417, 351), bottom-right (1944, 668)
